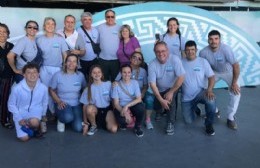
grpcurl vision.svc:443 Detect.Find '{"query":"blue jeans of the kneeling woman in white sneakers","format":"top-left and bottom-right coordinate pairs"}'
top-left (55, 104), bottom-right (82, 132)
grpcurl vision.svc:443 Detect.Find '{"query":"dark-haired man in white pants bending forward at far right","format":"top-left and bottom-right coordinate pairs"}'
top-left (199, 30), bottom-right (240, 130)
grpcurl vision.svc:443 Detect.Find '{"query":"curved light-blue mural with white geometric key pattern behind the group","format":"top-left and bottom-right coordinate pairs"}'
top-left (94, 2), bottom-right (260, 87)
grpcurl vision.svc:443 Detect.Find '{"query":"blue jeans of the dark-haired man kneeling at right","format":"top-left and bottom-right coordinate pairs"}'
top-left (181, 90), bottom-right (216, 125)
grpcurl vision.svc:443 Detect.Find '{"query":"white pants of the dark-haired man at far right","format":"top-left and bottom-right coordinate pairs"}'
top-left (214, 72), bottom-right (241, 121)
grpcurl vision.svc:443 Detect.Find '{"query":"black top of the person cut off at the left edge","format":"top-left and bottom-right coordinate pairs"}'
top-left (0, 42), bottom-right (14, 79)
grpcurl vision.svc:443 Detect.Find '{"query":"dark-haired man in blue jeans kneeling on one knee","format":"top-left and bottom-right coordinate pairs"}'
top-left (181, 41), bottom-right (216, 135)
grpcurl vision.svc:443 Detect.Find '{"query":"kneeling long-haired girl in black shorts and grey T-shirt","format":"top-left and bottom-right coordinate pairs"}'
top-left (80, 65), bottom-right (117, 135)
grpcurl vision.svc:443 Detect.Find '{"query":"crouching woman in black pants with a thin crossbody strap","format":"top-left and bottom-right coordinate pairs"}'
top-left (112, 64), bottom-right (145, 137)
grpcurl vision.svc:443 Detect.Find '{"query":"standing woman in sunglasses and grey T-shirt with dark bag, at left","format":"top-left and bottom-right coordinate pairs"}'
top-left (7, 20), bottom-right (39, 83)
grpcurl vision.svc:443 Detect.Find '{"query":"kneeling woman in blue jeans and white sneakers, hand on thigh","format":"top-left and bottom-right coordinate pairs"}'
top-left (49, 54), bottom-right (86, 132)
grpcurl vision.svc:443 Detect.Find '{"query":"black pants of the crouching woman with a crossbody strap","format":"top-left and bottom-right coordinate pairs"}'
top-left (114, 103), bottom-right (145, 128)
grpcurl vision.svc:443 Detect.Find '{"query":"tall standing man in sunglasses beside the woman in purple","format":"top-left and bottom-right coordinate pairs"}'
top-left (98, 9), bottom-right (120, 81)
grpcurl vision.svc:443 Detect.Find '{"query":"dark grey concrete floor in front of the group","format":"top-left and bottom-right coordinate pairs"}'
top-left (0, 86), bottom-right (260, 168)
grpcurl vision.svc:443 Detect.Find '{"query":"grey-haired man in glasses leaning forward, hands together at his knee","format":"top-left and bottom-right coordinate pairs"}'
top-left (148, 41), bottom-right (185, 135)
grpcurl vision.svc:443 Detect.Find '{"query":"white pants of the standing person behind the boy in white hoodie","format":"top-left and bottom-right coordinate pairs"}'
top-left (40, 66), bottom-right (61, 114)
